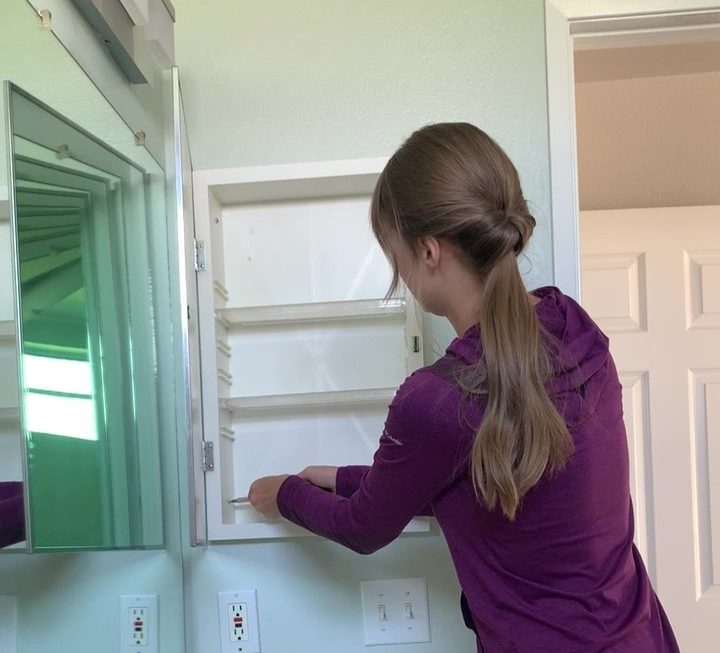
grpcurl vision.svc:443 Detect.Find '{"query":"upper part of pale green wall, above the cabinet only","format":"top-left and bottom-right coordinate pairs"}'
top-left (175, 0), bottom-right (552, 351)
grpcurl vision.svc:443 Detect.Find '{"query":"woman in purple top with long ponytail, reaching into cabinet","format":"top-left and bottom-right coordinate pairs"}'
top-left (250, 123), bottom-right (678, 653)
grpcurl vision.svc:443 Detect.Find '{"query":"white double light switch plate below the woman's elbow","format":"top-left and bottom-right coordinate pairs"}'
top-left (360, 578), bottom-right (430, 646)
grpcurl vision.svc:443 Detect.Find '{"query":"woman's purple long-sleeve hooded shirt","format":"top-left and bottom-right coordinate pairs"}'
top-left (278, 288), bottom-right (678, 653)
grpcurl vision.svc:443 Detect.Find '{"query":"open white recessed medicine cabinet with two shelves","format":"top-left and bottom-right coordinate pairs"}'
top-left (188, 159), bottom-right (429, 541)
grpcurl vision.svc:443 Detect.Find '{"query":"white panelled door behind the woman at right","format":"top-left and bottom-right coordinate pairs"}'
top-left (580, 206), bottom-right (720, 653)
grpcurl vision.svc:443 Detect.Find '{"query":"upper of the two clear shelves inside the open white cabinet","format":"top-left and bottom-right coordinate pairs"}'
top-left (219, 298), bottom-right (405, 327)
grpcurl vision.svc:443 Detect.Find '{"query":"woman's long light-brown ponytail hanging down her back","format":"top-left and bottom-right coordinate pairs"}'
top-left (470, 253), bottom-right (573, 519)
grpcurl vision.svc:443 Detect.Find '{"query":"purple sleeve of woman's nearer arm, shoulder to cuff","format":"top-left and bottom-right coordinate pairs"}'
top-left (277, 371), bottom-right (460, 553)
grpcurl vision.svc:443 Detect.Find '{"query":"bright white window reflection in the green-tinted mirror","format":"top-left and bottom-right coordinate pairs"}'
top-left (23, 355), bottom-right (98, 440)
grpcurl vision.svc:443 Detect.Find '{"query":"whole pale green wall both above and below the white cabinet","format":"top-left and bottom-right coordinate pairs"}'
top-left (174, 0), bottom-right (552, 653)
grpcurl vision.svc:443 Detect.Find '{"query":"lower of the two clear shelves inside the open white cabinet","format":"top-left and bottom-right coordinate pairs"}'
top-left (220, 388), bottom-right (396, 412)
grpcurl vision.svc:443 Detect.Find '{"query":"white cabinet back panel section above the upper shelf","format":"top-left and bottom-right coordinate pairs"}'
top-left (222, 196), bottom-right (391, 306)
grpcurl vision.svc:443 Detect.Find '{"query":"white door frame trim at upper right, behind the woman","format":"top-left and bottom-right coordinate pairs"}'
top-left (545, 0), bottom-right (720, 300)
